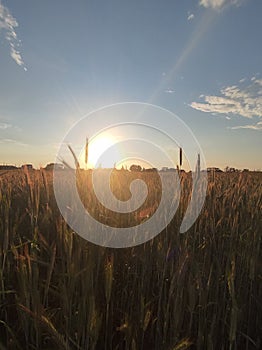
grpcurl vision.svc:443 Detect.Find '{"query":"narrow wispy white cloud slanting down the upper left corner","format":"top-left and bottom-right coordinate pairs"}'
top-left (0, 0), bottom-right (27, 71)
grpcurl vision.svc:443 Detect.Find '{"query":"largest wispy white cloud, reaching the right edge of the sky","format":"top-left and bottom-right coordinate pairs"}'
top-left (190, 79), bottom-right (262, 118)
